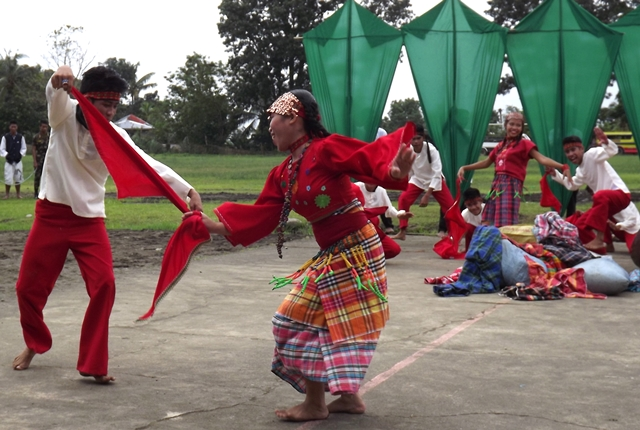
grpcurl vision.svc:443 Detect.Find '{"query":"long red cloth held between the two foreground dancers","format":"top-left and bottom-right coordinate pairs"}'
top-left (71, 88), bottom-right (211, 320)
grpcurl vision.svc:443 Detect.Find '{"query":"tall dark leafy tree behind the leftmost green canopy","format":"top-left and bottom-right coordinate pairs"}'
top-left (218, 0), bottom-right (412, 148)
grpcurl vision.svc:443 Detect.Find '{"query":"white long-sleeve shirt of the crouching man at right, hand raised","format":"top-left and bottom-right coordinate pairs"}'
top-left (551, 140), bottom-right (629, 193)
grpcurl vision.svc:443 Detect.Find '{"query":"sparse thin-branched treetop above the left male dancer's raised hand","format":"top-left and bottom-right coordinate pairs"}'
top-left (48, 25), bottom-right (95, 77)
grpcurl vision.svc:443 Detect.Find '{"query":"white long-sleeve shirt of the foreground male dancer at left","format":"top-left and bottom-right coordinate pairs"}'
top-left (38, 81), bottom-right (192, 218)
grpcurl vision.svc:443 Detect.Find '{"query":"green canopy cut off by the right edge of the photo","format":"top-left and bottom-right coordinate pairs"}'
top-left (611, 8), bottom-right (640, 158)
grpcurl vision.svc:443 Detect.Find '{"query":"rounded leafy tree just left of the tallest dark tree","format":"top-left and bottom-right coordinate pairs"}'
top-left (166, 53), bottom-right (237, 152)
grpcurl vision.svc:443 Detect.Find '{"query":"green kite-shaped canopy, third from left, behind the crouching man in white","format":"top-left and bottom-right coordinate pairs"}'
top-left (507, 0), bottom-right (622, 211)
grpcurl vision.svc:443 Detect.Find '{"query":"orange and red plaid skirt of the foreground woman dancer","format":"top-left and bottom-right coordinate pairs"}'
top-left (271, 224), bottom-right (389, 394)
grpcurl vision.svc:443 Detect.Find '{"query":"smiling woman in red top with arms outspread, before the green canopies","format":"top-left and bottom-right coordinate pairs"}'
top-left (458, 112), bottom-right (571, 227)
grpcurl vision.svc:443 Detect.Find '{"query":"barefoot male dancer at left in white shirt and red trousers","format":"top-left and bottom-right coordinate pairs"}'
top-left (13, 66), bottom-right (202, 383)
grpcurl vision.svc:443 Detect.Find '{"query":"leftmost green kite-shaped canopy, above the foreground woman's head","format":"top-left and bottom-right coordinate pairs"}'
top-left (303, 0), bottom-right (402, 142)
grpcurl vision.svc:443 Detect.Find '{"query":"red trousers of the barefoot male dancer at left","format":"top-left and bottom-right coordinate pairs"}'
top-left (16, 200), bottom-right (116, 376)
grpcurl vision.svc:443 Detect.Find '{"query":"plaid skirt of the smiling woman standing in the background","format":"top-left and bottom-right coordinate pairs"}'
top-left (482, 173), bottom-right (522, 227)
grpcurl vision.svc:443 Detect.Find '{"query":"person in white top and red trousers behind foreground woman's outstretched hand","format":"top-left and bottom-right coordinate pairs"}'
top-left (392, 125), bottom-right (454, 240)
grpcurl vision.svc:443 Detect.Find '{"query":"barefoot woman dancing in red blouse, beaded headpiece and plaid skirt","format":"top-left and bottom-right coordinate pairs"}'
top-left (185, 90), bottom-right (415, 421)
